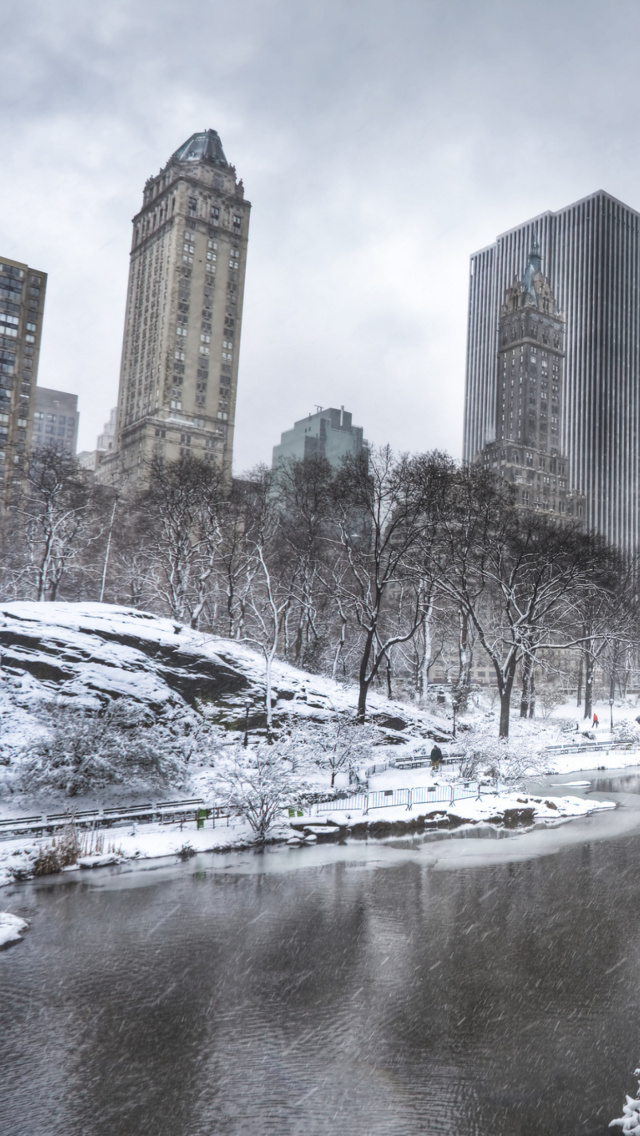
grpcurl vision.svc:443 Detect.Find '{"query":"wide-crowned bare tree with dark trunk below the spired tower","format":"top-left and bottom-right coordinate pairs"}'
top-left (429, 469), bottom-right (602, 737)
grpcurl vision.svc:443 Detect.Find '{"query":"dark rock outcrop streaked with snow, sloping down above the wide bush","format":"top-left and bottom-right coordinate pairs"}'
top-left (0, 601), bottom-right (447, 741)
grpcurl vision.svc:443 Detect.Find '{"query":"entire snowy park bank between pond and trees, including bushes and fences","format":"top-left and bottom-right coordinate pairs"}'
top-left (0, 602), bottom-right (640, 883)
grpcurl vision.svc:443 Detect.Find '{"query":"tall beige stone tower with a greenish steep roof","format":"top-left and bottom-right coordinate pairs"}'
top-left (99, 131), bottom-right (251, 482)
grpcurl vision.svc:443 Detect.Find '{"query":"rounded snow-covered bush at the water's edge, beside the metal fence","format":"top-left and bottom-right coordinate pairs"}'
top-left (215, 741), bottom-right (307, 843)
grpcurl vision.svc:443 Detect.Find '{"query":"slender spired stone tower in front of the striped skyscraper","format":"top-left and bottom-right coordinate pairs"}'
top-left (473, 242), bottom-right (584, 521)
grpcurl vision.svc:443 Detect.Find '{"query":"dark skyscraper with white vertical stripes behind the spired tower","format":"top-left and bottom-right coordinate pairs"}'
top-left (464, 191), bottom-right (640, 552)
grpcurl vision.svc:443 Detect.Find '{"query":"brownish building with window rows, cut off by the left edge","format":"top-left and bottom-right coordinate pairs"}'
top-left (0, 258), bottom-right (47, 503)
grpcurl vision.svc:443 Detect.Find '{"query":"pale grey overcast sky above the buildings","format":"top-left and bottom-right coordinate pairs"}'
top-left (0, 0), bottom-right (640, 471)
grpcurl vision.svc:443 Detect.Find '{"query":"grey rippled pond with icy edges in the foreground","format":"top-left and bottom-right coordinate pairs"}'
top-left (0, 771), bottom-right (640, 1136)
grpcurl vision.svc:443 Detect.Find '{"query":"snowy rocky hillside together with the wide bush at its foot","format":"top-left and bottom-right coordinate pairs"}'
top-left (0, 602), bottom-right (449, 808)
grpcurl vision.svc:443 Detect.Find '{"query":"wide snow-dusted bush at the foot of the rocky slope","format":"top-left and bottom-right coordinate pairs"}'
top-left (18, 699), bottom-right (189, 796)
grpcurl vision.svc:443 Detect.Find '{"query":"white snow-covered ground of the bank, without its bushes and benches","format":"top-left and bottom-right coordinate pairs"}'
top-left (0, 602), bottom-right (640, 879)
